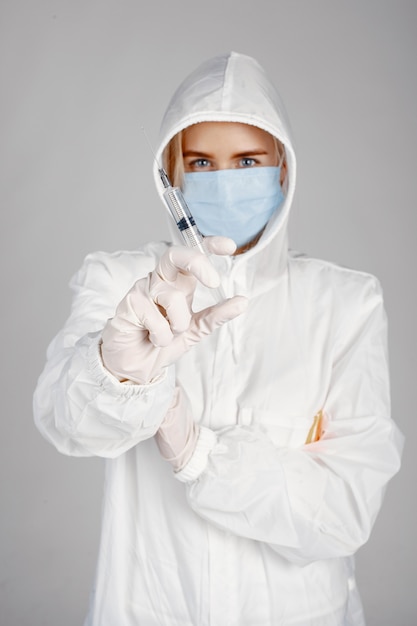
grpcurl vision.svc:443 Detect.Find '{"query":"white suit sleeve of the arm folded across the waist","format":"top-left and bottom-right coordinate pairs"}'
top-left (177, 278), bottom-right (402, 564)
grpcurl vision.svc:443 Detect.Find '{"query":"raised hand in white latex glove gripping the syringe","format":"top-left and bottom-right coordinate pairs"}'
top-left (101, 237), bottom-right (247, 384)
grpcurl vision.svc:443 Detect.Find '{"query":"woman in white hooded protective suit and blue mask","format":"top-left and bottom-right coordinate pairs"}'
top-left (35, 53), bottom-right (401, 626)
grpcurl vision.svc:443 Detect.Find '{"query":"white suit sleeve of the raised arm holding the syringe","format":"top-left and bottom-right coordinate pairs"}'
top-left (34, 253), bottom-right (174, 458)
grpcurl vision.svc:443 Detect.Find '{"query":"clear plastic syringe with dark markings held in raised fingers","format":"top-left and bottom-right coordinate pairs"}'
top-left (158, 164), bottom-right (226, 302)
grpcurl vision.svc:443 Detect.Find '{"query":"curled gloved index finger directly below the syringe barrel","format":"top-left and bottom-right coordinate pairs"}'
top-left (156, 246), bottom-right (220, 287)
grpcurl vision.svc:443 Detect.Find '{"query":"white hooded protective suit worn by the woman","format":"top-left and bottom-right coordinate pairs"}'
top-left (35, 53), bottom-right (402, 626)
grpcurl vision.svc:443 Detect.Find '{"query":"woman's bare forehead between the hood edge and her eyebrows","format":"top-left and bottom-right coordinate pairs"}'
top-left (183, 122), bottom-right (274, 150)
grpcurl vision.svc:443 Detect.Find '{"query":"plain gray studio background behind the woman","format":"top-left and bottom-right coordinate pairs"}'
top-left (0, 0), bottom-right (417, 626)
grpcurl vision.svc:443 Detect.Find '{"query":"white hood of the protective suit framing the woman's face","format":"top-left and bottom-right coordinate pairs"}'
top-left (154, 52), bottom-right (296, 295)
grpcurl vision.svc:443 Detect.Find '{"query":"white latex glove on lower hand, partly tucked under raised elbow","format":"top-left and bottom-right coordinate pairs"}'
top-left (155, 387), bottom-right (198, 472)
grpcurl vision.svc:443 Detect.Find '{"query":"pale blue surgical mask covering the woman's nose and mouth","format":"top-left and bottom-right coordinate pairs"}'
top-left (183, 167), bottom-right (284, 248)
